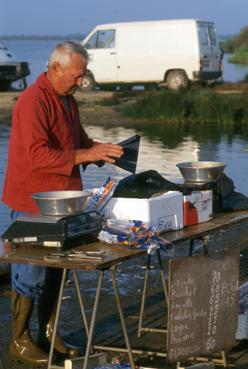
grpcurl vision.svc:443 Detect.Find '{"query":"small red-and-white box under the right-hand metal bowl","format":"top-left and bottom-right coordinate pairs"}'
top-left (183, 190), bottom-right (213, 227)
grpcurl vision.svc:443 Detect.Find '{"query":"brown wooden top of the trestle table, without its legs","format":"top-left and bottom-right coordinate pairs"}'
top-left (0, 210), bottom-right (248, 270)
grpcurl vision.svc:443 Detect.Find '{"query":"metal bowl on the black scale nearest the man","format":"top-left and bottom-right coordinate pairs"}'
top-left (32, 191), bottom-right (92, 215)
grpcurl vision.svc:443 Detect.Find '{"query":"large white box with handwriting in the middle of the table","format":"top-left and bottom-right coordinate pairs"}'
top-left (103, 191), bottom-right (183, 231)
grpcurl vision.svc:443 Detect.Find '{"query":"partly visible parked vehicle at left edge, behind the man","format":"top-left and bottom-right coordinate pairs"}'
top-left (0, 41), bottom-right (30, 91)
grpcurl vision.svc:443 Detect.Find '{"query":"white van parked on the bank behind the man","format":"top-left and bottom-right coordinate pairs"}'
top-left (82, 19), bottom-right (222, 90)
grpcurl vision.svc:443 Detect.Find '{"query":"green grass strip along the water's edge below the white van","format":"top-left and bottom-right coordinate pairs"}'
top-left (120, 89), bottom-right (248, 124)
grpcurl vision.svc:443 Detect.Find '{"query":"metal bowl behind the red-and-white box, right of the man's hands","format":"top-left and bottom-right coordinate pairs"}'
top-left (177, 161), bottom-right (226, 183)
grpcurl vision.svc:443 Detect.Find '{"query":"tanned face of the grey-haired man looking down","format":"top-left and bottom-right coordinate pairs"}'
top-left (51, 54), bottom-right (86, 96)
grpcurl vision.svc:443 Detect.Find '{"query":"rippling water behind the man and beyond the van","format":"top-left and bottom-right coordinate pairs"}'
top-left (0, 40), bottom-right (248, 234)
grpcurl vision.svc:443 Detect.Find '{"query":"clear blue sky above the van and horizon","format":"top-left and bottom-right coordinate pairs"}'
top-left (0, 0), bottom-right (248, 36)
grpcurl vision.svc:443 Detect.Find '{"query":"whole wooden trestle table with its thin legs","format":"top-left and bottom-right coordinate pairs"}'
top-left (0, 211), bottom-right (248, 369)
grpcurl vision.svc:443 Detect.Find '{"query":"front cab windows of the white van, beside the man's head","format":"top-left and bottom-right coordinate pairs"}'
top-left (86, 29), bottom-right (115, 49)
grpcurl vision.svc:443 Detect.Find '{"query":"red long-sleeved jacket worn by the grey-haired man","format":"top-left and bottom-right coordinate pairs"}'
top-left (2, 73), bottom-right (93, 212)
